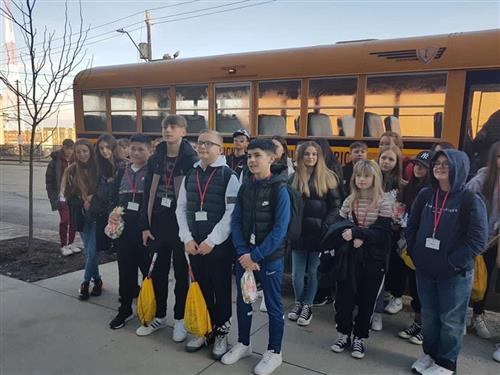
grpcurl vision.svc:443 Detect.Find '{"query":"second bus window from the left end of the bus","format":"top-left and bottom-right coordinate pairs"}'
top-left (110, 89), bottom-right (137, 133)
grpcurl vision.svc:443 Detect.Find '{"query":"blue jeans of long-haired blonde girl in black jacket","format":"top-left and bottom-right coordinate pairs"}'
top-left (292, 250), bottom-right (319, 306)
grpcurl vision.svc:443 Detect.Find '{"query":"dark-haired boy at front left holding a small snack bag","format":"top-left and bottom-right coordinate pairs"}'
top-left (109, 134), bottom-right (153, 329)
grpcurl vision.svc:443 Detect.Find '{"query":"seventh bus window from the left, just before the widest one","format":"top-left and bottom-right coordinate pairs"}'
top-left (307, 78), bottom-right (357, 137)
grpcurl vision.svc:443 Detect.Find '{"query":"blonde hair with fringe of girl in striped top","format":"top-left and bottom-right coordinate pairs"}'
top-left (346, 160), bottom-right (384, 210)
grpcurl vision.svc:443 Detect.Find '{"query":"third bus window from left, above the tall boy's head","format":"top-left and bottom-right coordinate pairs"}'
top-left (142, 87), bottom-right (170, 133)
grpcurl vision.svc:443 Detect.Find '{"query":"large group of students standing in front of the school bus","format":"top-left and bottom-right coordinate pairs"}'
top-left (45, 115), bottom-right (500, 375)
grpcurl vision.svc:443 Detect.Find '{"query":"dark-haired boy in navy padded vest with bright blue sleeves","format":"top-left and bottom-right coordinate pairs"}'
top-left (222, 139), bottom-right (291, 375)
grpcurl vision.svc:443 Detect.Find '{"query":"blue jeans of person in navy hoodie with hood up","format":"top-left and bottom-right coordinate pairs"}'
top-left (417, 270), bottom-right (473, 371)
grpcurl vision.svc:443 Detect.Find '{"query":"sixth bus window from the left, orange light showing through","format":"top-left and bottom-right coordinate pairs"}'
top-left (258, 80), bottom-right (300, 135)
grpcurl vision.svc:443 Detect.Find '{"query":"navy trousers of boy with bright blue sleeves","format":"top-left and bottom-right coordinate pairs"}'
top-left (235, 258), bottom-right (285, 353)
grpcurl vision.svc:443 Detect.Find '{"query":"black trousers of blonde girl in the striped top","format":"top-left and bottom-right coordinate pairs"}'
top-left (335, 266), bottom-right (384, 338)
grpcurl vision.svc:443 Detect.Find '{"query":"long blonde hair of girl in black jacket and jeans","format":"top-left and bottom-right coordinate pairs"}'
top-left (292, 141), bottom-right (338, 198)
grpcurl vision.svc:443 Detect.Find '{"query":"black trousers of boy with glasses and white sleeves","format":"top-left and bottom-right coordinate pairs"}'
top-left (189, 241), bottom-right (234, 328)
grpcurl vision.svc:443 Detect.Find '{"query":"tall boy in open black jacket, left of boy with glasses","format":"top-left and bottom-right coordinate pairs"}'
top-left (136, 115), bottom-right (197, 342)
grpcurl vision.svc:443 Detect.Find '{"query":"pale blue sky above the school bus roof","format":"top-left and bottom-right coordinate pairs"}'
top-left (0, 0), bottom-right (500, 129)
